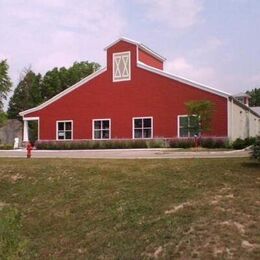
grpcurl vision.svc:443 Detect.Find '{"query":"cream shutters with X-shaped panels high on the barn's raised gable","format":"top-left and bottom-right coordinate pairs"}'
top-left (113, 51), bottom-right (131, 81)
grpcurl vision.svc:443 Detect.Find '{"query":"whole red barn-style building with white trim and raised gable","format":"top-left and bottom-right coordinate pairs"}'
top-left (20, 38), bottom-right (259, 141)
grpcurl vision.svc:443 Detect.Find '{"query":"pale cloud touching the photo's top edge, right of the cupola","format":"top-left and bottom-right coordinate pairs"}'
top-left (138, 0), bottom-right (203, 29)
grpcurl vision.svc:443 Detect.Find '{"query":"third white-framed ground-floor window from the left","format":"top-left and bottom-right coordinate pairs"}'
top-left (133, 117), bottom-right (153, 139)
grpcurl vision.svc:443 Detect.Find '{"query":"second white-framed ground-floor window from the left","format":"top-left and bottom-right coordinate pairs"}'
top-left (92, 119), bottom-right (111, 139)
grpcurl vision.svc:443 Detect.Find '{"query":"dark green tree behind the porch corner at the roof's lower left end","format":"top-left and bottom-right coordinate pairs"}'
top-left (7, 69), bottom-right (42, 119)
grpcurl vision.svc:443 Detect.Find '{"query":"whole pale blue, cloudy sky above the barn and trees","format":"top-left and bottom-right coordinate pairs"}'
top-left (0, 0), bottom-right (260, 106)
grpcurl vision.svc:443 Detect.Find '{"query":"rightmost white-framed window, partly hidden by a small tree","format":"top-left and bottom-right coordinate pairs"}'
top-left (179, 115), bottom-right (199, 137)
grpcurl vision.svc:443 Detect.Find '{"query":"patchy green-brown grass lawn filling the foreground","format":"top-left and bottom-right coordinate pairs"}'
top-left (0, 158), bottom-right (260, 259)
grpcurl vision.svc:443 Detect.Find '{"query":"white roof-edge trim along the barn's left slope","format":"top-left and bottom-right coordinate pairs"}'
top-left (19, 67), bottom-right (107, 116)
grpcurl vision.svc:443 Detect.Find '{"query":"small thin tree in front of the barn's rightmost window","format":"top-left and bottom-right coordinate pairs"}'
top-left (185, 100), bottom-right (215, 134)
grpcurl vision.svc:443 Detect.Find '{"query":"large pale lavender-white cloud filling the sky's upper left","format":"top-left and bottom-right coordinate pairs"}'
top-left (0, 0), bottom-right (126, 78)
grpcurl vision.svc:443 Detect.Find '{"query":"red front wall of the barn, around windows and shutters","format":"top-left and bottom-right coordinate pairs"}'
top-left (26, 41), bottom-right (227, 140)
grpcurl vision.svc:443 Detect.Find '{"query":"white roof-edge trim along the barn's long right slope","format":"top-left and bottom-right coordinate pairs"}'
top-left (137, 62), bottom-right (230, 98)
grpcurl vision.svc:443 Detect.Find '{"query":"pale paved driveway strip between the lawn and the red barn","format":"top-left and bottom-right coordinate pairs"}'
top-left (0, 149), bottom-right (250, 159)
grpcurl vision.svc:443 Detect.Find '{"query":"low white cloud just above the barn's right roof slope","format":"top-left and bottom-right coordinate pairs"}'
top-left (165, 57), bottom-right (216, 86)
